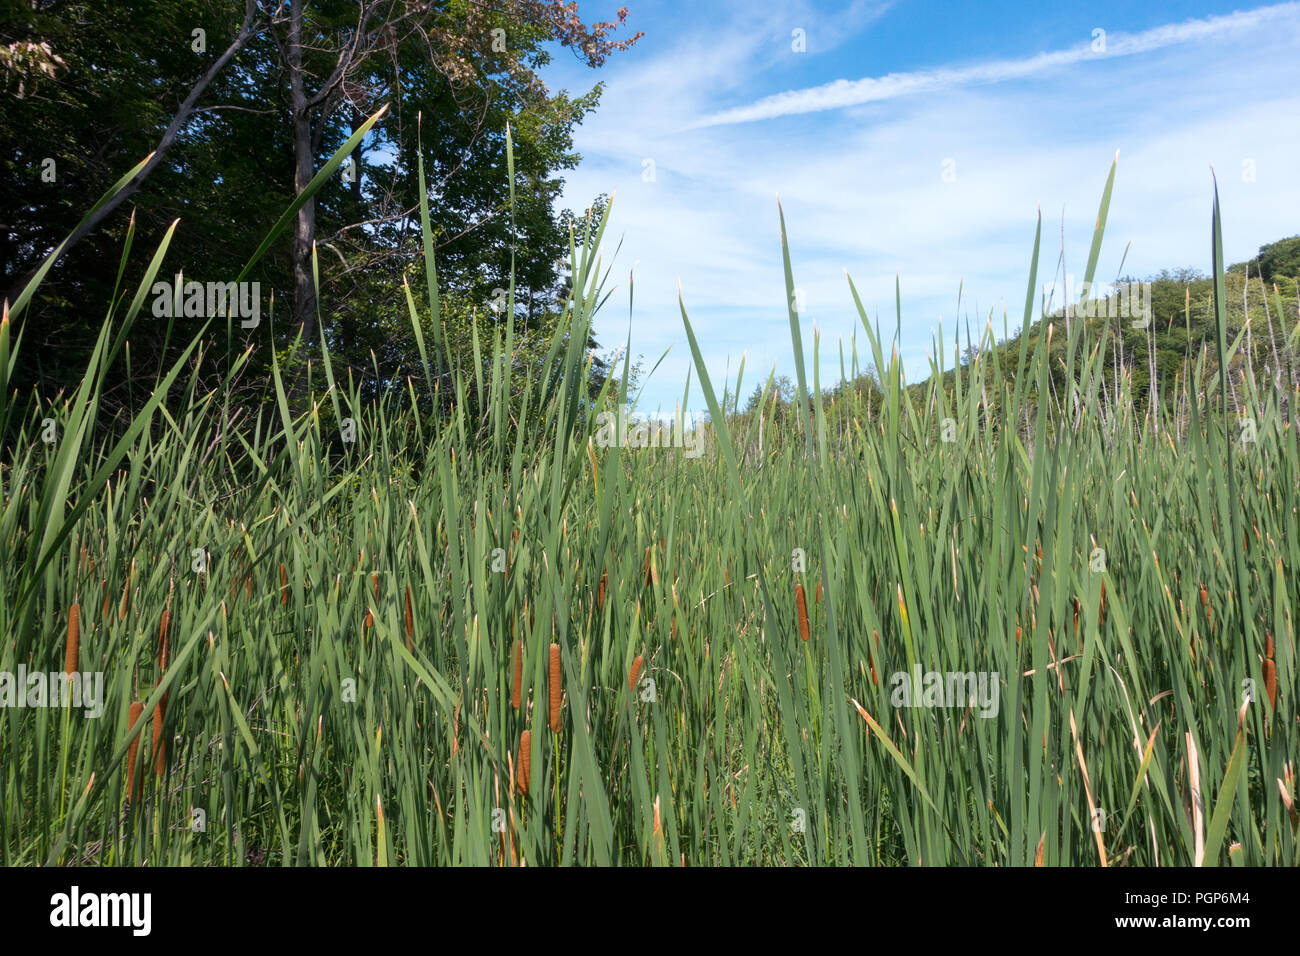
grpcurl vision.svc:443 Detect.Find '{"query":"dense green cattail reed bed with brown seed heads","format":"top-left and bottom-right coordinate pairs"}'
top-left (0, 141), bottom-right (1300, 866)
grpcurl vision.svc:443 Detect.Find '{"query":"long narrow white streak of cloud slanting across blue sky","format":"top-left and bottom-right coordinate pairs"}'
top-left (685, 3), bottom-right (1300, 129)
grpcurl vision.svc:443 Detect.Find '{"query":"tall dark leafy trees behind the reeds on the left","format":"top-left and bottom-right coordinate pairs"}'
top-left (0, 0), bottom-right (640, 416)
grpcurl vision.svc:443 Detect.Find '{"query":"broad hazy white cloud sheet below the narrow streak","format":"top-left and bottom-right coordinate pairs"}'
top-left (553, 4), bottom-right (1300, 408)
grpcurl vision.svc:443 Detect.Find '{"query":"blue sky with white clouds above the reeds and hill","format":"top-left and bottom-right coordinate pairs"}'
top-left (543, 0), bottom-right (1300, 414)
